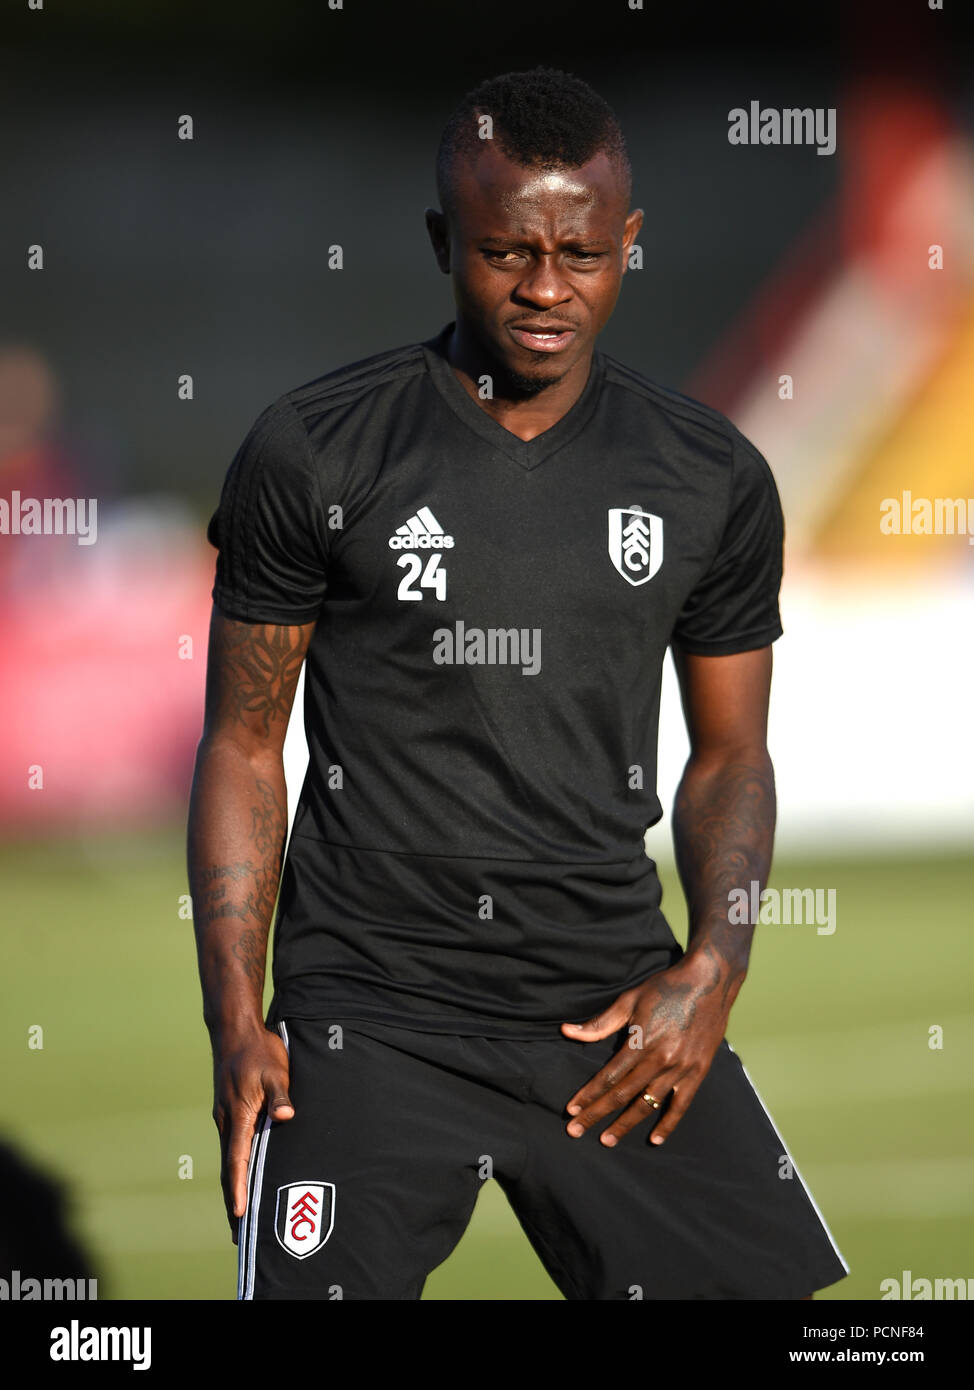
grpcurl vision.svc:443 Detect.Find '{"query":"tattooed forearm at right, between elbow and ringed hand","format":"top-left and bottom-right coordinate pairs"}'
top-left (674, 755), bottom-right (775, 1002)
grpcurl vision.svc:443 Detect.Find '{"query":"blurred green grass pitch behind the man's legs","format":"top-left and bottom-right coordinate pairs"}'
top-left (0, 827), bottom-right (974, 1300)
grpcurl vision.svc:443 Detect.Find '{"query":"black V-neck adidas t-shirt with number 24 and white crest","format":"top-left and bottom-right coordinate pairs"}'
top-left (207, 325), bottom-right (784, 1037)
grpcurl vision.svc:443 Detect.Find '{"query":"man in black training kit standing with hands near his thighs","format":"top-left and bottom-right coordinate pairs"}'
top-left (189, 70), bottom-right (846, 1300)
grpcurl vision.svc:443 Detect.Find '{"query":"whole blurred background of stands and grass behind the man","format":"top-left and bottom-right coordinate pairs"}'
top-left (0, 0), bottom-right (974, 1300)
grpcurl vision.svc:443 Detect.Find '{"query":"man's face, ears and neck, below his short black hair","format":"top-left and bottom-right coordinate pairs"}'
top-left (427, 140), bottom-right (642, 439)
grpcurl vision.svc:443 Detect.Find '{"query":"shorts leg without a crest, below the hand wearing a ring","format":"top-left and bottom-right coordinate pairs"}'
top-left (504, 1036), bottom-right (848, 1300)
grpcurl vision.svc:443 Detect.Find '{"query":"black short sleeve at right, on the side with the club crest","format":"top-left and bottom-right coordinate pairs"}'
top-left (671, 431), bottom-right (785, 656)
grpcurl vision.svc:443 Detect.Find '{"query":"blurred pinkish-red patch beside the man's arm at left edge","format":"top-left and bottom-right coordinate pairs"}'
top-left (0, 514), bottom-right (214, 831)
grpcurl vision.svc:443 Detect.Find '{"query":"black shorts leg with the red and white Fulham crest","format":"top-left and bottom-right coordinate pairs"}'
top-left (238, 1019), bottom-right (481, 1300)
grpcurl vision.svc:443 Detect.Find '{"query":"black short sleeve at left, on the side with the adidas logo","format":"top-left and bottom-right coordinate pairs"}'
top-left (207, 398), bottom-right (327, 624)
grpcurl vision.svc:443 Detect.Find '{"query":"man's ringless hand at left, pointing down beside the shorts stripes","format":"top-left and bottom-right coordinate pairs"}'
top-left (213, 1024), bottom-right (295, 1245)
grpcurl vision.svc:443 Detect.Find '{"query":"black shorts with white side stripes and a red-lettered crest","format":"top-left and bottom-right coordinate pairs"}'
top-left (238, 1019), bottom-right (849, 1300)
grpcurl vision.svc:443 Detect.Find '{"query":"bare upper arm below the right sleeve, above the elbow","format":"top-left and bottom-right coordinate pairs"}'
top-left (671, 642), bottom-right (771, 758)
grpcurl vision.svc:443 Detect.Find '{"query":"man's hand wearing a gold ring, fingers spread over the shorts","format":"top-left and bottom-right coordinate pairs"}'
top-left (561, 947), bottom-right (739, 1148)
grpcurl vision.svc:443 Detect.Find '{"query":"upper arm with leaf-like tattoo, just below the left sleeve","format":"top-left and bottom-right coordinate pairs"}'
top-left (203, 603), bottom-right (315, 755)
